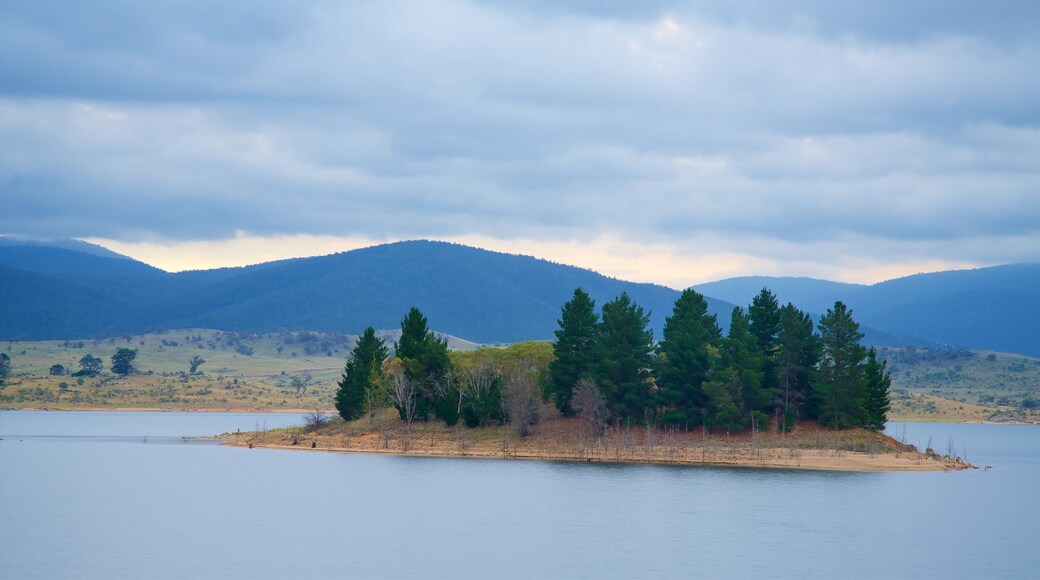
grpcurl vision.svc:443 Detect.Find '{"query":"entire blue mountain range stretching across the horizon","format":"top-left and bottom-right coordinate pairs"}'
top-left (0, 238), bottom-right (1040, 355)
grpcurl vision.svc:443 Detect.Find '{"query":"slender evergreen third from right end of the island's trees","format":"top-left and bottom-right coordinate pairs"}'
top-left (773, 302), bottom-right (820, 430)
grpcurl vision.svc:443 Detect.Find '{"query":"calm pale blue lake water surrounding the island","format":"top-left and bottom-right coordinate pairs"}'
top-left (0, 412), bottom-right (1040, 580)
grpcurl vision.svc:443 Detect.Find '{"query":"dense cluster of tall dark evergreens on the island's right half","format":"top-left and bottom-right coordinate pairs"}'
top-left (548, 288), bottom-right (891, 432)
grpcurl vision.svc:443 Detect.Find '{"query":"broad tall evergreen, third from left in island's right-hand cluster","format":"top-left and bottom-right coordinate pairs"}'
top-left (656, 289), bottom-right (722, 428)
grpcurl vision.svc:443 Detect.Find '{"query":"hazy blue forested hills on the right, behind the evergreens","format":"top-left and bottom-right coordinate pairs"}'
top-left (694, 264), bottom-right (1040, 357)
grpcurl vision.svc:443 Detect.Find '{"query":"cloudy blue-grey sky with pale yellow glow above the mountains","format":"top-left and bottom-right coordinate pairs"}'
top-left (0, 0), bottom-right (1040, 288)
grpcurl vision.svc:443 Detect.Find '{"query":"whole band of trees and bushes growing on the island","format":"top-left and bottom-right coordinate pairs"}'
top-left (336, 288), bottom-right (891, 436)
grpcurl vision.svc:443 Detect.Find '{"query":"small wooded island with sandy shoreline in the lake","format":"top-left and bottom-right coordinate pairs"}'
top-left (223, 288), bottom-right (971, 471)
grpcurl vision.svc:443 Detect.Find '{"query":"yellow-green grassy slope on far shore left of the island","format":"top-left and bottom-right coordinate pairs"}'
top-left (0, 328), bottom-right (378, 411)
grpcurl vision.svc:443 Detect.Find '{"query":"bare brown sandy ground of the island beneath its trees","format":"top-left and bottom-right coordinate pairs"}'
top-left (215, 419), bottom-right (972, 472)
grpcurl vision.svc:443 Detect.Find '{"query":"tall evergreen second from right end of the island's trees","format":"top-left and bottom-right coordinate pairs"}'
top-left (814, 301), bottom-right (866, 429)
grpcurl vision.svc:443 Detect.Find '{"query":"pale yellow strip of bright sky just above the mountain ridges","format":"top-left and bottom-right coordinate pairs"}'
top-left (85, 233), bottom-right (977, 289)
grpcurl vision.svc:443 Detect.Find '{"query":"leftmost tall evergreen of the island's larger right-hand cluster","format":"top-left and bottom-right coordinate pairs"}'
top-left (549, 288), bottom-right (598, 416)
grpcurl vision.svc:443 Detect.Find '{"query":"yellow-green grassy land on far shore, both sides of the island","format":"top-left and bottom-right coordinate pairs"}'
top-left (0, 328), bottom-right (1040, 422)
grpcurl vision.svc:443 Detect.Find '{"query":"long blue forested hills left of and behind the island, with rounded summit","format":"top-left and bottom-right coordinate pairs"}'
top-left (0, 241), bottom-right (733, 343)
